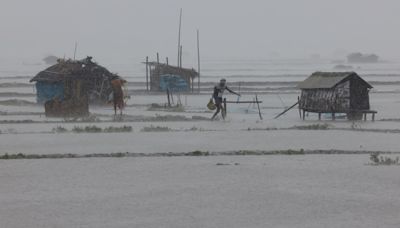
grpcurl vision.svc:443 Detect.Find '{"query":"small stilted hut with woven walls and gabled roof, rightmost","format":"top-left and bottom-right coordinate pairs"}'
top-left (298, 72), bottom-right (372, 118)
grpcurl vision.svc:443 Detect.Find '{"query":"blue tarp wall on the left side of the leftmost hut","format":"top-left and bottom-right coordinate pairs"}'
top-left (36, 82), bottom-right (64, 103)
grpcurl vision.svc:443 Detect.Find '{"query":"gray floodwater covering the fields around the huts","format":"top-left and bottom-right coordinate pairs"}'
top-left (0, 59), bottom-right (400, 228)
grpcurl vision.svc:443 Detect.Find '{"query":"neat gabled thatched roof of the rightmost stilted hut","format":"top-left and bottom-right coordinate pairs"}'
top-left (297, 72), bottom-right (372, 89)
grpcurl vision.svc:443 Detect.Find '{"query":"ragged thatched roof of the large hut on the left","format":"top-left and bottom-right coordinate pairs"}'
top-left (30, 57), bottom-right (118, 82)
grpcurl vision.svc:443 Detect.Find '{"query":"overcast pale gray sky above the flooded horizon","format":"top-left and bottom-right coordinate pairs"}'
top-left (0, 0), bottom-right (400, 62)
